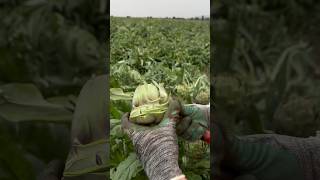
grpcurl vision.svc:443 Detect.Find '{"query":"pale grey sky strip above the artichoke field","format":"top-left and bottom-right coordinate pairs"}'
top-left (110, 0), bottom-right (210, 17)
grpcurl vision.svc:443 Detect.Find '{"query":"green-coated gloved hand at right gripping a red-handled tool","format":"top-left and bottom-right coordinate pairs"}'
top-left (177, 104), bottom-right (210, 143)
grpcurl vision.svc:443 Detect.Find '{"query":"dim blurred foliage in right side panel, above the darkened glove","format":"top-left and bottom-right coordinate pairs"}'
top-left (211, 0), bottom-right (320, 137)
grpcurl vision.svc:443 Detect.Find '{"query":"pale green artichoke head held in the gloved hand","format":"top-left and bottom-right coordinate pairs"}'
top-left (129, 82), bottom-right (169, 124)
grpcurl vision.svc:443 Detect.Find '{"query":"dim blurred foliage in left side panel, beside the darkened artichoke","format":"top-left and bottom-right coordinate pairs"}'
top-left (0, 0), bottom-right (109, 180)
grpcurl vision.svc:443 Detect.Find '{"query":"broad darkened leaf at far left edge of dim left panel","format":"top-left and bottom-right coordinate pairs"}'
top-left (0, 83), bottom-right (72, 122)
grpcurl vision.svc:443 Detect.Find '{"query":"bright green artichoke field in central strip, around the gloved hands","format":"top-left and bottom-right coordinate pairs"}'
top-left (110, 17), bottom-right (210, 180)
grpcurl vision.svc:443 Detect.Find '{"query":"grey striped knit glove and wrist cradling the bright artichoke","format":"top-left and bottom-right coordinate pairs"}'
top-left (122, 100), bottom-right (185, 180)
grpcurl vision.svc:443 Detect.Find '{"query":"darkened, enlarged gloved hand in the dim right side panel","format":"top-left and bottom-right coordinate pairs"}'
top-left (213, 122), bottom-right (304, 180)
